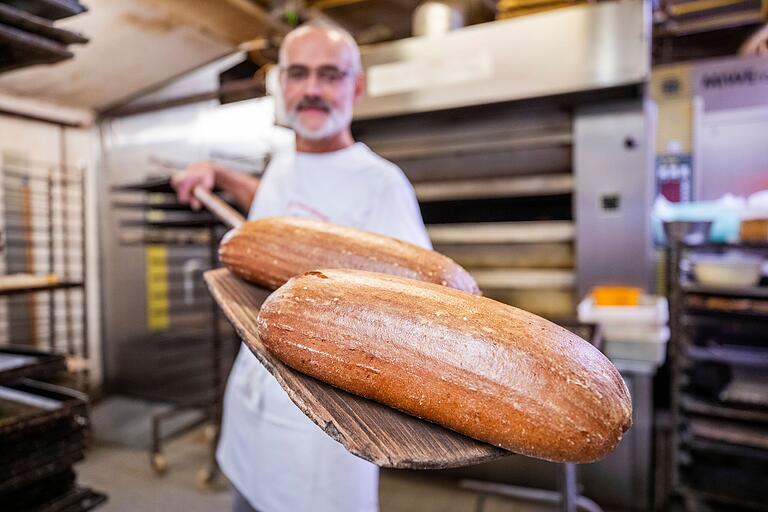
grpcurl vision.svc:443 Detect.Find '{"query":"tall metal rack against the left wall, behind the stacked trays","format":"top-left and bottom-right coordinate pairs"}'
top-left (0, 159), bottom-right (91, 391)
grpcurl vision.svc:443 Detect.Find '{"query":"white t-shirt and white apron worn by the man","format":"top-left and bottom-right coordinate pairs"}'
top-left (217, 143), bottom-right (431, 512)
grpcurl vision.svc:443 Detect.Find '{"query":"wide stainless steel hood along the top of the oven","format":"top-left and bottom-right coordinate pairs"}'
top-left (355, 0), bottom-right (651, 119)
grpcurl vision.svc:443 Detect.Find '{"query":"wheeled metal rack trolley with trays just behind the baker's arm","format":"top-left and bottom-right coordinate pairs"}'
top-left (112, 177), bottom-right (236, 487)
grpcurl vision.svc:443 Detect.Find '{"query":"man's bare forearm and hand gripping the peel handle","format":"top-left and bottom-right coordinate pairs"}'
top-left (171, 161), bottom-right (261, 212)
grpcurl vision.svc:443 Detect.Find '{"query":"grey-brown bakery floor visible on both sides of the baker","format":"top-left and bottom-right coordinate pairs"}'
top-left (75, 397), bottom-right (556, 512)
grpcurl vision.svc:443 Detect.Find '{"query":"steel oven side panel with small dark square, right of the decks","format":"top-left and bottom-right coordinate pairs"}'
top-left (574, 102), bottom-right (654, 296)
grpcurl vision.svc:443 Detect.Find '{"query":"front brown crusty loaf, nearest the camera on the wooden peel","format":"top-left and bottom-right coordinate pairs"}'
top-left (258, 270), bottom-right (632, 463)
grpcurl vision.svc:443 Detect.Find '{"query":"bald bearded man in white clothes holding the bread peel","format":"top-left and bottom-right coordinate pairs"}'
top-left (172, 19), bottom-right (431, 512)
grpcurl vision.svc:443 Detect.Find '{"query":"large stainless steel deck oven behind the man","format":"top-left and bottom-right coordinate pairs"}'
top-left (353, 1), bottom-right (655, 510)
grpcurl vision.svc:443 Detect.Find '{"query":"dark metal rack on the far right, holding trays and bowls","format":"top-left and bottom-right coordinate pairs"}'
top-left (669, 244), bottom-right (768, 511)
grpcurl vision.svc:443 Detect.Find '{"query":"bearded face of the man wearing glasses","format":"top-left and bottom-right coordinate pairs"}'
top-left (280, 29), bottom-right (363, 140)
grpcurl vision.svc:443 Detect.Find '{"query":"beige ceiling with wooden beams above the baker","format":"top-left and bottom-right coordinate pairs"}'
top-left (0, 0), bottom-right (768, 119)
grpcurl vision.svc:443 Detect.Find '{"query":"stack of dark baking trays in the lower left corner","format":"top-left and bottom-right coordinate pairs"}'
top-left (0, 370), bottom-right (106, 512)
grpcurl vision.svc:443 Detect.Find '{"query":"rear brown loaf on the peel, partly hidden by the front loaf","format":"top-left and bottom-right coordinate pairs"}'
top-left (219, 217), bottom-right (480, 294)
